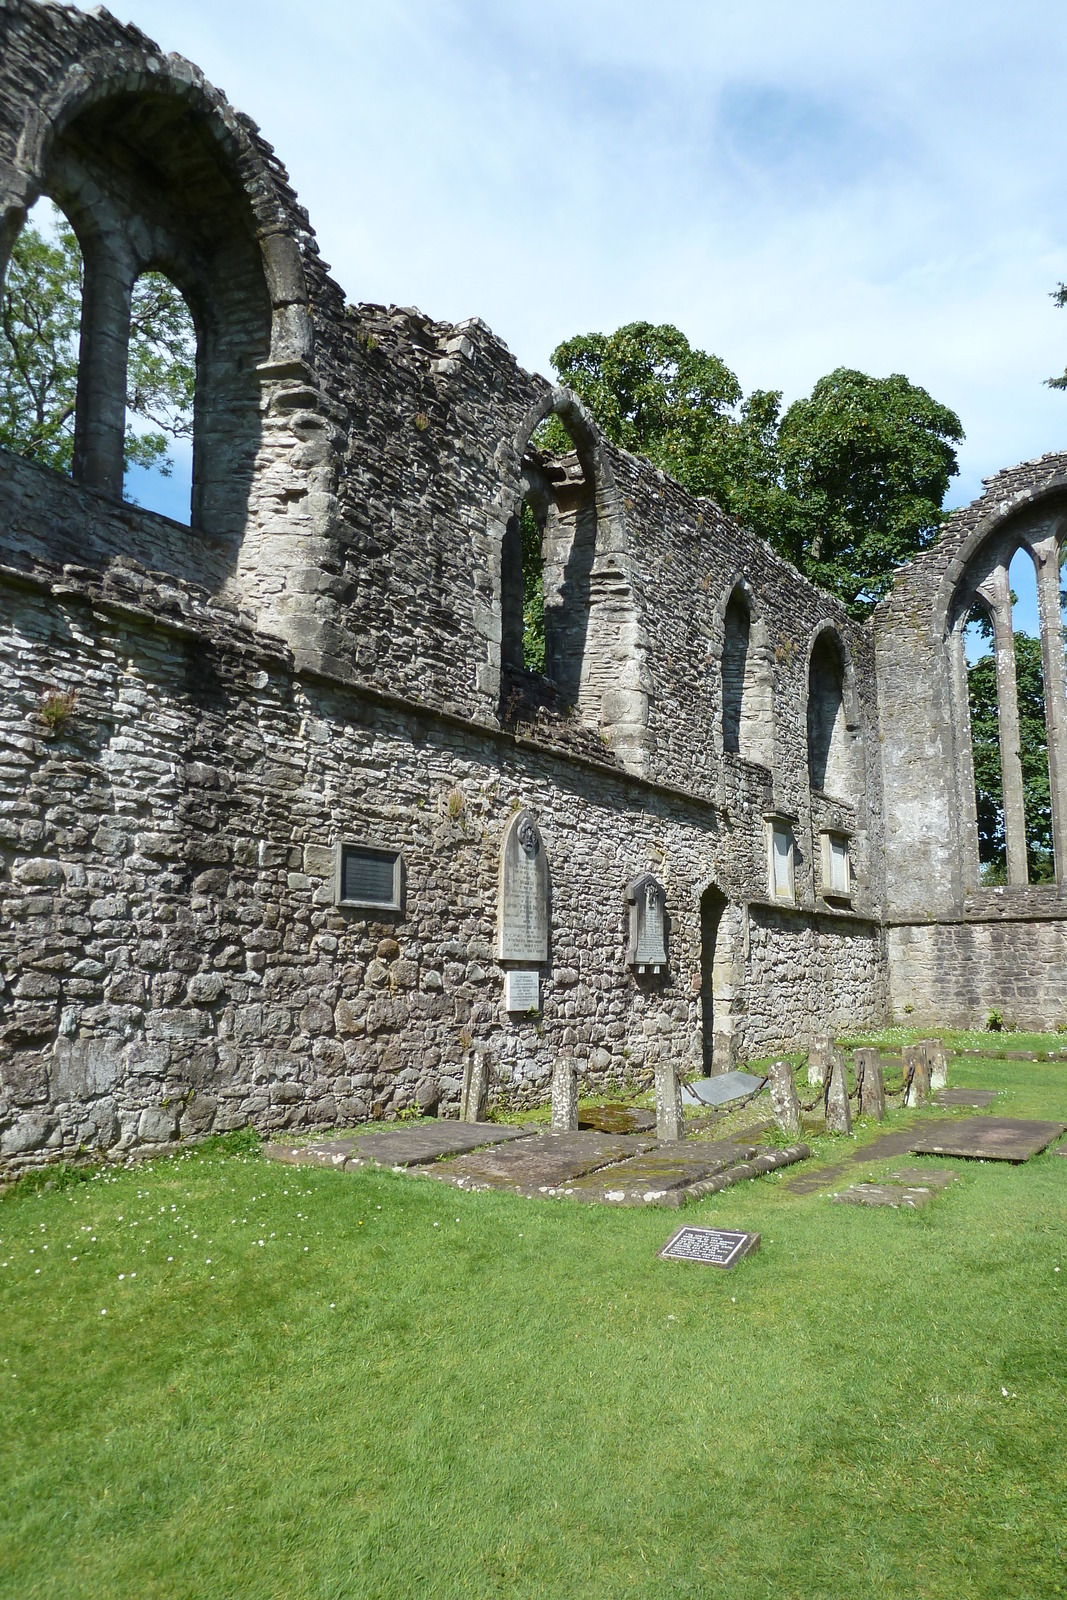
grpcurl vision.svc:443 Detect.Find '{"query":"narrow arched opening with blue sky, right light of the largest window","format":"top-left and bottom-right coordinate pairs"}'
top-left (123, 270), bottom-right (197, 522)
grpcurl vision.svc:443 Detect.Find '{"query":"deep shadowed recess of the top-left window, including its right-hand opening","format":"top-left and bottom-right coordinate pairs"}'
top-left (12, 85), bottom-right (272, 555)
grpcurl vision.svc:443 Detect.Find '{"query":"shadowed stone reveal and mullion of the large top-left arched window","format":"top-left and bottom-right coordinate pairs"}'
top-left (5, 74), bottom-right (272, 542)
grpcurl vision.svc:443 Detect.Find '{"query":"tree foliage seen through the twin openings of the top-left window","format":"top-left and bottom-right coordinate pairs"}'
top-left (0, 206), bottom-right (197, 477)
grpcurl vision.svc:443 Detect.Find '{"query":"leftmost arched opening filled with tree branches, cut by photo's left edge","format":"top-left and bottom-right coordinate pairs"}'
top-left (0, 198), bottom-right (85, 474)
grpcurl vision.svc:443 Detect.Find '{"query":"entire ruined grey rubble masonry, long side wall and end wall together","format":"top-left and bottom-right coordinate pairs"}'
top-left (0, 0), bottom-right (1067, 1168)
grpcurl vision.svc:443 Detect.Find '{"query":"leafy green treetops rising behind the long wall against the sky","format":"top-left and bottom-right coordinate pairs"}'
top-left (552, 322), bottom-right (963, 618)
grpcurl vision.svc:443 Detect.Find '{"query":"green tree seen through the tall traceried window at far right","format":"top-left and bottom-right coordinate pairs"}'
top-left (968, 611), bottom-right (1054, 883)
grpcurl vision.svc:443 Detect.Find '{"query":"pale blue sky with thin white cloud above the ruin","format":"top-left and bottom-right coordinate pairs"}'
top-left (103, 0), bottom-right (1067, 524)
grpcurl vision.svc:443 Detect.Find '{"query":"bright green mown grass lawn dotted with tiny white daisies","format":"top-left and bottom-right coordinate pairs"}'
top-left (0, 1035), bottom-right (1067, 1600)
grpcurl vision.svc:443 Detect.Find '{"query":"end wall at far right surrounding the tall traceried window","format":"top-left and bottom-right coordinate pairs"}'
top-left (872, 456), bottom-right (1067, 1027)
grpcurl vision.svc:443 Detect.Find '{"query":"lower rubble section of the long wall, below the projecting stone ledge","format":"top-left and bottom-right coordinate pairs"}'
top-left (0, 570), bottom-right (883, 1165)
